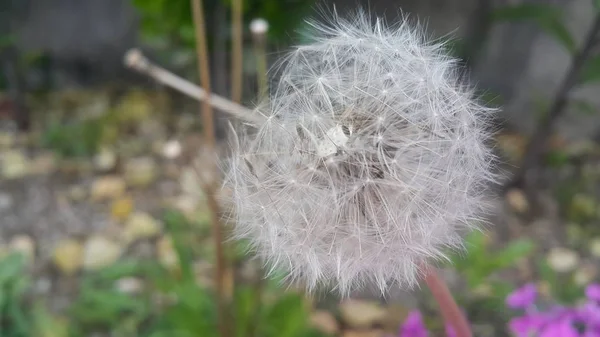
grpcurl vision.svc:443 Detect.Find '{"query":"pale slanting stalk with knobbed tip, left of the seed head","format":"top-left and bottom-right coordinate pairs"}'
top-left (125, 49), bottom-right (263, 123)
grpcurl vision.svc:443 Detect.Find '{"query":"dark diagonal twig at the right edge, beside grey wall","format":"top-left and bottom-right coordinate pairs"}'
top-left (507, 14), bottom-right (600, 195)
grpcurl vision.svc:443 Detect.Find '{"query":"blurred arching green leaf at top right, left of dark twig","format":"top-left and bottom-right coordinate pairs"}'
top-left (492, 4), bottom-right (576, 53)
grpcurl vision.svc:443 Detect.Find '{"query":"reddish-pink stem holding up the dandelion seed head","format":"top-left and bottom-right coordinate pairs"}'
top-left (425, 267), bottom-right (473, 337)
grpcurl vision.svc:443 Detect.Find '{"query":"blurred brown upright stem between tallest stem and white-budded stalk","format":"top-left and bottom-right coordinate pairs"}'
top-left (231, 0), bottom-right (243, 103)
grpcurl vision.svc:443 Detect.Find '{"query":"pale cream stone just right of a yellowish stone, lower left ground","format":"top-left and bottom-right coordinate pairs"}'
top-left (83, 235), bottom-right (123, 270)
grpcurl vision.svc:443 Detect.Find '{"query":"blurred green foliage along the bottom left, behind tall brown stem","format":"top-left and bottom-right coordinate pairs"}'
top-left (0, 211), bottom-right (322, 337)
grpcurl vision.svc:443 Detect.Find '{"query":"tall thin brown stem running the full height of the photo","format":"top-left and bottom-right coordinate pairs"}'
top-left (191, 0), bottom-right (231, 337)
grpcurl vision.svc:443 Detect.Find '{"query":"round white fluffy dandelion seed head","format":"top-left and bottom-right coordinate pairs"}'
top-left (225, 9), bottom-right (494, 294)
